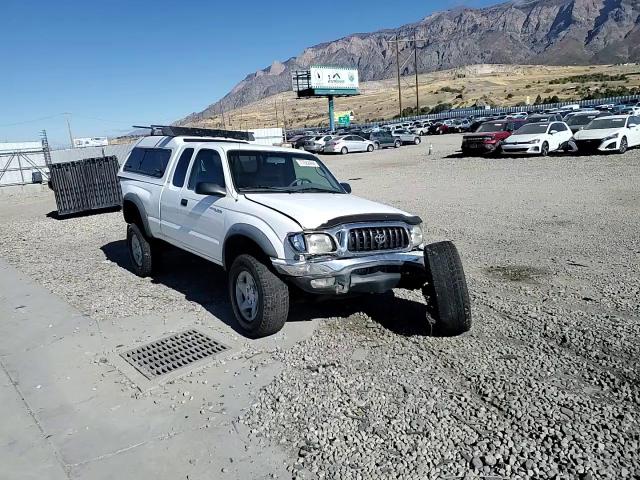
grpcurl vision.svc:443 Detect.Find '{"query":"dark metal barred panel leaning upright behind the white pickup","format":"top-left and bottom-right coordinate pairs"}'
top-left (50, 156), bottom-right (122, 216)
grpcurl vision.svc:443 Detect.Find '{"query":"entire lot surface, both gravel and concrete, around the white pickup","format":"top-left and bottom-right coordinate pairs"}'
top-left (0, 135), bottom-right (640, 479)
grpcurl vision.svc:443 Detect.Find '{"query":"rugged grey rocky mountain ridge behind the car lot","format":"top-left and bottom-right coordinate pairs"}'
top-left (181, 0), bottom-right (640, 122)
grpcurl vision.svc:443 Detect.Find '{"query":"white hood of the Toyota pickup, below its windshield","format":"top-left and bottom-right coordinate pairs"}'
top-left (245, 193), bottom-right (410, 230)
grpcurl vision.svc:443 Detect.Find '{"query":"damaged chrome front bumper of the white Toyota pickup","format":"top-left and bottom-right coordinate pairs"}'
top-left (271, 250), bottom-right (425, 295)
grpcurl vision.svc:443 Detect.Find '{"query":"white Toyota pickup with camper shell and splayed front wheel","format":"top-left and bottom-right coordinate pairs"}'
top-left (118, 126), bottom-right (471, 338)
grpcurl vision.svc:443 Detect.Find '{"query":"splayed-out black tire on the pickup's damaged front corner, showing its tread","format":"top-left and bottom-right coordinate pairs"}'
top-left (423, 242), bottom-right (471, 336)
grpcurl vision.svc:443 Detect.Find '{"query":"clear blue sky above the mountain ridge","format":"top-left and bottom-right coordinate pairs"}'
top-left (0, 0), bottom-right (497, 146)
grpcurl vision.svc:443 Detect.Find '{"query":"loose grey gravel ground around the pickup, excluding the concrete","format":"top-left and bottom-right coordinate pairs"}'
top-left (0, 136), bottom-right (640, 479)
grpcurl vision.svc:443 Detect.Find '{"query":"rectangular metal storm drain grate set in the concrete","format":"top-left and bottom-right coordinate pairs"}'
top-left (120, 330), bottom-right (229, 380)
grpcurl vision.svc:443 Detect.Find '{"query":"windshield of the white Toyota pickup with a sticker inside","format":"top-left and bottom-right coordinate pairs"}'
top-left (227, 150), bottom-right (345, 193)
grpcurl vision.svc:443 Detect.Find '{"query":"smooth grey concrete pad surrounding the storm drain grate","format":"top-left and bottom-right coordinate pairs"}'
top-left (0, 260), bottom-right (315, 479)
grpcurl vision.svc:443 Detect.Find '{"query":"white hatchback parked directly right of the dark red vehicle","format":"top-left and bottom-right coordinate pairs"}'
top-left (502, 122), bottom-right (573, 157)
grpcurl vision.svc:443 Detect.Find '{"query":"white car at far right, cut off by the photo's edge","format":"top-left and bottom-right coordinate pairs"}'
top-left (575, 115), bottom-right (640, 153)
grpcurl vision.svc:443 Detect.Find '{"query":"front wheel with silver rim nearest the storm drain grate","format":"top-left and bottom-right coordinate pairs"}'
top-left (228, 255), bottom-right (289, 338)
